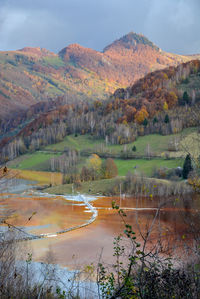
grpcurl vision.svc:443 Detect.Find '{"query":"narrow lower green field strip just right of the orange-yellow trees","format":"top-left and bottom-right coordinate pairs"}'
top-left (114, 158), bottom-right (183, 176)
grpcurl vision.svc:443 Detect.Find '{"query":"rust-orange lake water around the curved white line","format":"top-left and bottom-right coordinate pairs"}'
top-left (1, 182), bottom-right (200, 268)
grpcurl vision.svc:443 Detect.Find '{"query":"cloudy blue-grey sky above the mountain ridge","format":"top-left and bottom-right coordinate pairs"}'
top-left (0, 0), bottom-right (200, 54)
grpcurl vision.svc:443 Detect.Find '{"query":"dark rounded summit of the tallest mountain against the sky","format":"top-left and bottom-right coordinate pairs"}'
top-left (103, 32), bottom-right (160, 52)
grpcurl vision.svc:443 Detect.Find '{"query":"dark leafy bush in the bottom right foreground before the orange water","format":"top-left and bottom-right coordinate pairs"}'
top-left (97, 203), bottom-right (200, 299)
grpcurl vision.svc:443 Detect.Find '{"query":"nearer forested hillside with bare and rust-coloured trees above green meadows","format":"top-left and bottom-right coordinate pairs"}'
top-left (1, 60), bottom-right (200, 163)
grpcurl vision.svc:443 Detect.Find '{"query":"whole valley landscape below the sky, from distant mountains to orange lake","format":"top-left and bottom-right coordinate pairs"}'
top-left (0, 32), bottom-right (200, 299)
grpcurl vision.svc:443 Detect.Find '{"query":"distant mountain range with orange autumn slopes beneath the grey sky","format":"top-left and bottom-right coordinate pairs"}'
top-left (0, 32), bottom-right (200, 119)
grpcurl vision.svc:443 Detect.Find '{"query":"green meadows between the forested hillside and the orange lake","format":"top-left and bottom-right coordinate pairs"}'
top-left (8, 128), bottom-right (197, 183)
